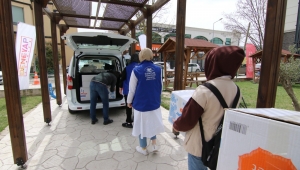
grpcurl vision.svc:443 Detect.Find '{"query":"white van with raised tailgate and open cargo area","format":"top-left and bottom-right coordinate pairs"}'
top-left (62, 32), bottom-right (136, 113)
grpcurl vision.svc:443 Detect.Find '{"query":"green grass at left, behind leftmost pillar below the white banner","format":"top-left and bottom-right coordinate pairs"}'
top-left (0, 96), bottom-right (42, 132)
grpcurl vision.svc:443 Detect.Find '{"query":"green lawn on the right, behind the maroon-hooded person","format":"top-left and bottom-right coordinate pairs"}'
top-left (161, 81), bottom-right (300, 110)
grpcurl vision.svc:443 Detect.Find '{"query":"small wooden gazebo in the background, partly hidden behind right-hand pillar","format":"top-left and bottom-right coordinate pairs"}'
top-left (249, 50), bottom-right (300, 82)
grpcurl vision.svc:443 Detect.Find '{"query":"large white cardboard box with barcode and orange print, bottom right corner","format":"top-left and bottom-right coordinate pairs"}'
top-left (217, 108), bottom-right (300, 170)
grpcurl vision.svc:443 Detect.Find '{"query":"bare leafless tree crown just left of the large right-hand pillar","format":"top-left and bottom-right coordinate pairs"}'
top-left (224, 0), bottom-right (267, 50)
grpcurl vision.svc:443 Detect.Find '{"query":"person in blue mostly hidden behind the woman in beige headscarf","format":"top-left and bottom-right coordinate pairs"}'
top-left (119, 54), bottom-right (140, 128)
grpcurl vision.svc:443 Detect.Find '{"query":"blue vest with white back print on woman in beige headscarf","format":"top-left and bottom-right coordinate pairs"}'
top-left (132, 61), bottom-right (162, 112)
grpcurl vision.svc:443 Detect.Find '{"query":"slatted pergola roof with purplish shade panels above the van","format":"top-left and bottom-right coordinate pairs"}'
top-left (46, 0), bottom-right (170, 34)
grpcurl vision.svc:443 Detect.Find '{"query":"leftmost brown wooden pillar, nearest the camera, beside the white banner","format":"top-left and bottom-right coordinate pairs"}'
top-left (0, 1), bottom-right (28, 166)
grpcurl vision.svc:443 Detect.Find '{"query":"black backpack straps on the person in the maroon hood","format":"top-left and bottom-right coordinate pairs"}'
top-left (199, 83), bottom-right (240, 144)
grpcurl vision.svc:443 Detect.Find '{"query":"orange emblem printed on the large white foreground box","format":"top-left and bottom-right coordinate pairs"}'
top-left (238, 148), bottom-right (297, 170)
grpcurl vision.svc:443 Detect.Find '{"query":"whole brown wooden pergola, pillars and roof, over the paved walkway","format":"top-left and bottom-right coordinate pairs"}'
top-left (0, 0), bottom-right (287, 166)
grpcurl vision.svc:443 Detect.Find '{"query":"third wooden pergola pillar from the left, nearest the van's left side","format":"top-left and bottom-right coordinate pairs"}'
top-left (50, 17), bottom-right (62, 106)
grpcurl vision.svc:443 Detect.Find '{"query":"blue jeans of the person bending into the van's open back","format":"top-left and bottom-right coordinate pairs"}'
top-left (90, 81), bottom-right (109, 121)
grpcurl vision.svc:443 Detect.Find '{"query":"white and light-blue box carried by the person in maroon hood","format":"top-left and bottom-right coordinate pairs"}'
top-left (168, 90), bottom-right (195, 124)
